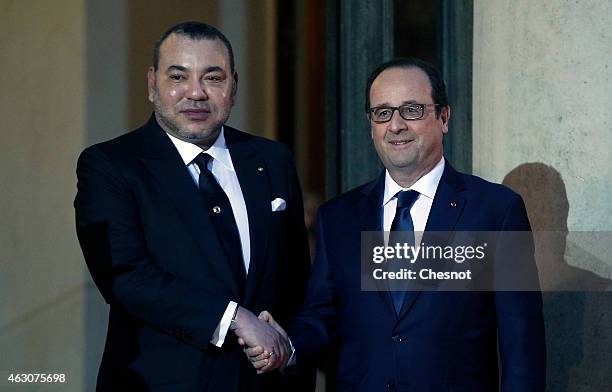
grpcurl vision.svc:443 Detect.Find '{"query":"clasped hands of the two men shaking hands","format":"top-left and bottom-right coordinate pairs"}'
top-left (233, 307), bottom-right (292, 374)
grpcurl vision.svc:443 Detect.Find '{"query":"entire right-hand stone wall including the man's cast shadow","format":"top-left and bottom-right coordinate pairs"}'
top-left (473, 0), bottom-right (612, 392)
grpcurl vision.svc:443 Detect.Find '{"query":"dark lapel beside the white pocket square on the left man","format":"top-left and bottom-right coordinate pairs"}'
top-left (225, 126), bottom-right (272, 303)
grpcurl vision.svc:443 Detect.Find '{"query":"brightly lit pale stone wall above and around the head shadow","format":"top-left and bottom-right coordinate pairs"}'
top-left (473, 0), bottom-right (612, 230)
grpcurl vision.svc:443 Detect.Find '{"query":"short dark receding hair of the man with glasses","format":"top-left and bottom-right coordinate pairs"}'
top-left (365, 57), bottom-right (448, 117)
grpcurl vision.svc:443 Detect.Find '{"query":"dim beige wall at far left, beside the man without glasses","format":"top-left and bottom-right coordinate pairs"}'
top-left (0, 0), bottom-right (86, 391)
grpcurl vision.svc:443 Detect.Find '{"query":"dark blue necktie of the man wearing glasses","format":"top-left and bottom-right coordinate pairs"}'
top-left (388, 190), bottom-right (419, 314)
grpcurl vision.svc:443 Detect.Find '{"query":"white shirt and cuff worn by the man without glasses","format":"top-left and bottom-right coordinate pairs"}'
top-left (166, 127), bottom-right (246, 347)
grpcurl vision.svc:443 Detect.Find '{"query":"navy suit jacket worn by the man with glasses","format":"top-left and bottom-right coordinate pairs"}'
top-left (289, 163), bottom-right (545, 392)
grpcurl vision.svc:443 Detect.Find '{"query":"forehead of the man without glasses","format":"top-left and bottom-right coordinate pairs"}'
top-left (159, 34), bottom-right (229, 70)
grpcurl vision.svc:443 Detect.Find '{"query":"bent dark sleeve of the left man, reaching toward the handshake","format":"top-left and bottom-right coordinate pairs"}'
top-left (74, 146), bottom-right (231, 348)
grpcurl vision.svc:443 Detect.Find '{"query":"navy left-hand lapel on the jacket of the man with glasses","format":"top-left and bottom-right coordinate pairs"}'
top-left (357, 175), bottom-right (396, 316)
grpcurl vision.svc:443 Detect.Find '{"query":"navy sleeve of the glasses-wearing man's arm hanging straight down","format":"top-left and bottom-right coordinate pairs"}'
top-left (495, 196), bottom-right (546, 392)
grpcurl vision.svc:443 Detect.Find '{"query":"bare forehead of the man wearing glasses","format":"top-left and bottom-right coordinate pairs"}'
top-left (370, 67), bottom-right (432, 107)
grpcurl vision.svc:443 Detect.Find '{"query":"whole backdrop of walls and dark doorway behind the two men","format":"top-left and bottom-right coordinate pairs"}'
top-left (0, 0), bottom-right (612, 391)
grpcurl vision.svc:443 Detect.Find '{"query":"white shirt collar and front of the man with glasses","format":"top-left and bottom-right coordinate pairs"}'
top-left (382, 158), bottom-right (444, 245)
